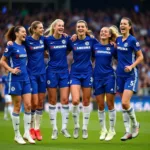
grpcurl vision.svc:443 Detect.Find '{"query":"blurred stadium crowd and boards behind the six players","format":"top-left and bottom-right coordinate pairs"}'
top-left (0, 0), bottom-right (150, 111)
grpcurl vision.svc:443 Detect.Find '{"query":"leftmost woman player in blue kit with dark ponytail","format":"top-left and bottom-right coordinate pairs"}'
top-left (1, 26), bottom-right (35, 144)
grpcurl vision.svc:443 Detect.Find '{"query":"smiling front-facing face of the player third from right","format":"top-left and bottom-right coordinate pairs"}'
top-left (76, 22), bottom-right (88, 36)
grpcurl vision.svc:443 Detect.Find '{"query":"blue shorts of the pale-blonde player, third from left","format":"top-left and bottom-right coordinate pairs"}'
top-left (46, 72), bottom-right (70, 88)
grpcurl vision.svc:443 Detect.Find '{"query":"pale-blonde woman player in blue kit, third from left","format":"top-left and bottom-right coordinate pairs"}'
top-left (45, 19), bottom-right (71, 140)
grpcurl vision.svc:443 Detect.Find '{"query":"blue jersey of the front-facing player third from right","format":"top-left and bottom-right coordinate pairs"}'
top-left (70, 36), bottom-right (98, 74)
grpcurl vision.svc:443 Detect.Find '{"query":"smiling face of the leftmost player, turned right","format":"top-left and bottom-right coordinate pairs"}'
top-left (15, 27), bottom-right (27, 41)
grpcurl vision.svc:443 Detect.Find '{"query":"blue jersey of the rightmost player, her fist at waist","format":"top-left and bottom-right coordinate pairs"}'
top-left (116, 35), bottom-right (141, 77)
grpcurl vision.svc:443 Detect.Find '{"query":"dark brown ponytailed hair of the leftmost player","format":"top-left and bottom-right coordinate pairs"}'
top-left (5, 26), bottom-right (23, 41)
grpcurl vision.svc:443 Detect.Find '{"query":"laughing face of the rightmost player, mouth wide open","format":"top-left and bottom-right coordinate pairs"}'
top-left (120, 19), bottom-right (131, 34)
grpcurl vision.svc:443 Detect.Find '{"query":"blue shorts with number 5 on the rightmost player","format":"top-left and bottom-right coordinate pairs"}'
top-left (117, 76), bottom-right (138, 93)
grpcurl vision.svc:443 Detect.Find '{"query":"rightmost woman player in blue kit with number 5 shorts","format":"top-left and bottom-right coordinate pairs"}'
top-left (116, 17), bottom-right (143, 141)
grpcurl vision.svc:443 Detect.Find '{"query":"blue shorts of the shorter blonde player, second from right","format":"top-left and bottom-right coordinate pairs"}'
top-left (93, 76), bottom-right (117, 96)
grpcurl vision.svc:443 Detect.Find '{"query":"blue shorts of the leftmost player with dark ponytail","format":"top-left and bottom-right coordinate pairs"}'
top-left (8, 80), bottom-right (31, 95)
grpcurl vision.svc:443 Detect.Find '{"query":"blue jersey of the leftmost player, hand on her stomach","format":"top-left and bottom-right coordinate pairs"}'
top-left (3, 42), bottom-right (29, 81)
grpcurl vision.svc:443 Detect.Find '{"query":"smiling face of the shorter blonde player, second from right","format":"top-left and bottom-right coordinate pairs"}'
top-left (100, 27), bottom-right (111, 40)
